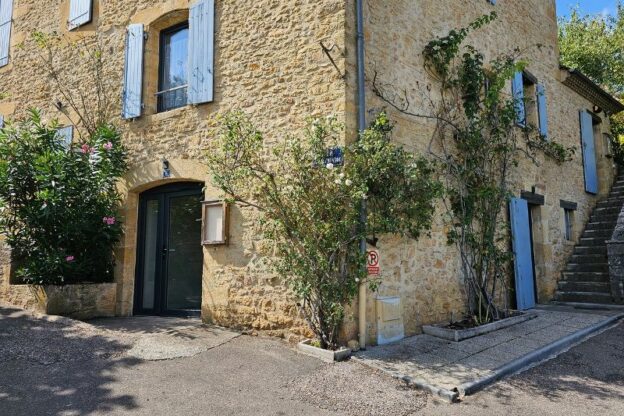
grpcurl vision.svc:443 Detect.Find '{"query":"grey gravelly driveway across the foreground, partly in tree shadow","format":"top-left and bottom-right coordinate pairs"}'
top-left (0, 308), bottom-right (624, 416)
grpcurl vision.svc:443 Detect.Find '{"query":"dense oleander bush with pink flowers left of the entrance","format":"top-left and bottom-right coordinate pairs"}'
top-left (0, 110), bottom-right (126, 285)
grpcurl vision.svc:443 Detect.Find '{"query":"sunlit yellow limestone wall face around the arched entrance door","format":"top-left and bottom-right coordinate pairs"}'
top-left (0, 0), bottom-right (351, 342)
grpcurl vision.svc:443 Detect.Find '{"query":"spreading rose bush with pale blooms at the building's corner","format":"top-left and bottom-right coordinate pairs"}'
top-left (208, 113), bottom-right (440, 349)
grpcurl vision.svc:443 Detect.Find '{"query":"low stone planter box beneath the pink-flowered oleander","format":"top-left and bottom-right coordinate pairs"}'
top-left (29, 283), bottom-right (117, 320)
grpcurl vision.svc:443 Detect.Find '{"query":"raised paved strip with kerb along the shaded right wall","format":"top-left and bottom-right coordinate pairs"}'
top-left (356, 307), bottom-right (622, 393)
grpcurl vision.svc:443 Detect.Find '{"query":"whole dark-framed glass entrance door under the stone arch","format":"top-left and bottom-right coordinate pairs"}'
top-left (134, 183), bottom-right (203, 316)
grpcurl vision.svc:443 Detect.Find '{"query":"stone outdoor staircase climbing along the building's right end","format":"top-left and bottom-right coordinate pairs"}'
top-left (555, 174), bottom-right (624, 304)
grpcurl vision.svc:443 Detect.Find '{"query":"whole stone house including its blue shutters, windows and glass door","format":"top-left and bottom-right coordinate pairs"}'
top-left (0, 0), bottom-right (622, 343)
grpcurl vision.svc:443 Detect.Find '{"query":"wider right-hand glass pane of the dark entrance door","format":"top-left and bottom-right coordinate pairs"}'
top-left (167, 195), bottom-right (203, 310)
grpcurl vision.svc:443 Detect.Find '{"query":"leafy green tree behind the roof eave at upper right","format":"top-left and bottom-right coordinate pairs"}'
top-left (559, 5), bottom-right (624, 159)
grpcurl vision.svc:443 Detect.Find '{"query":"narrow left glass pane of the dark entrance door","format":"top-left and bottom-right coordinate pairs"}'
top-left (143, 199), bottom-right (159, 309)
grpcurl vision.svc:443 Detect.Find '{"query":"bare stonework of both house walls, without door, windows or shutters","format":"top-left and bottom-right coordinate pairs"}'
top-left (0, 0), bottom-right (614, 342)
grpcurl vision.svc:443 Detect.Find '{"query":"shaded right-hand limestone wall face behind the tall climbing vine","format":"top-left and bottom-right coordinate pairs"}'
top-left (347, 0), bottom-right (614, 342)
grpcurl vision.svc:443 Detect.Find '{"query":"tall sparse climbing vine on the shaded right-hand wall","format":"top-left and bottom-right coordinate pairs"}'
top-left (373, 13), bottom-right (574, 324)
